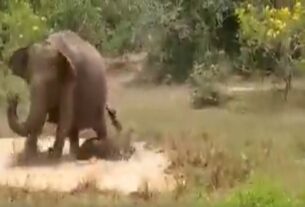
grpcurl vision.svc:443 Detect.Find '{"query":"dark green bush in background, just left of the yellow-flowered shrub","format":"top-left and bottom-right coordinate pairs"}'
top-left (139, 0), bottom-right (238, 82)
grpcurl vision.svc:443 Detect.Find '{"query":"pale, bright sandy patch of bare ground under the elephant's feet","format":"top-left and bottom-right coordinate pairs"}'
top-left (0, 138), bottom-right (175, 194)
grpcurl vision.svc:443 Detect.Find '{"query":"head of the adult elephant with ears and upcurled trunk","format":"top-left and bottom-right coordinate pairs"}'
top-left (7, 32), bottom-right (75, 139)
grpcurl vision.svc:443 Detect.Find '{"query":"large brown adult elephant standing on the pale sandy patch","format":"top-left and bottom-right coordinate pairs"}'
top-left (7, 31), bottom-right (121, 158)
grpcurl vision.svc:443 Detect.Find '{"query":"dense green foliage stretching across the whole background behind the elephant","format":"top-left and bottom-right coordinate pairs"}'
top-left (0, 0), bottom-right (305, 105)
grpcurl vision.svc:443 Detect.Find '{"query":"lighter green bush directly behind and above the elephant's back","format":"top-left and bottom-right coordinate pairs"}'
top-left (42, 0), bottom-right (150, 55)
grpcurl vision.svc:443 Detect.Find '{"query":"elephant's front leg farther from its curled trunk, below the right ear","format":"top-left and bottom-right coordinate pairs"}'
top-left (50, 82), bottom-right (74, 159)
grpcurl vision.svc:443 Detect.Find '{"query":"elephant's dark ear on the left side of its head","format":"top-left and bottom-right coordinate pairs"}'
top-left (8, 47), bottom-right (29, 78)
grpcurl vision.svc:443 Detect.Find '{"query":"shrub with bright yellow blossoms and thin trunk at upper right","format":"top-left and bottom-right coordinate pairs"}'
top-left (236, 0), bottom-right (305, 98)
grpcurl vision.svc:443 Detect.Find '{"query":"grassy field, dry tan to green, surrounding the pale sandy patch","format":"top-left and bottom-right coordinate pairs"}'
top-left (0, 79), bottom-right (305, 207)
